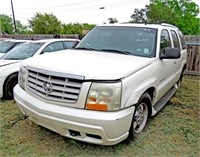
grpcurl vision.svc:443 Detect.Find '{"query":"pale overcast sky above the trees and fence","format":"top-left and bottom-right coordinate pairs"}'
top-left (0, 0), bottom-right (200, 25)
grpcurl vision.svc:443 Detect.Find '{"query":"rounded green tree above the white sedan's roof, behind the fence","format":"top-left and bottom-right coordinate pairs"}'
top-left (28, 13), bottom-right (61, 34)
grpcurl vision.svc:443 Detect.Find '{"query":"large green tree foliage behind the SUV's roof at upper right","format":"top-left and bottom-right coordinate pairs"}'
top-left (130, 0), bottom-right (200, 34)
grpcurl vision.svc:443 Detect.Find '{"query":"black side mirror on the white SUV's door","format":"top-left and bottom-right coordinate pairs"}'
top-left (160, 48), bottom-right (181, 59)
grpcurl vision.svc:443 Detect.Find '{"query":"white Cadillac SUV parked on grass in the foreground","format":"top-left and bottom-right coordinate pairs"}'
top-left (14, 24), bottom-right (187, 145)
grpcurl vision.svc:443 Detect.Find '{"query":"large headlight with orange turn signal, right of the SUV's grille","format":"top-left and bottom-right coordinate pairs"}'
top-left (86, 82), bottom-right (121, 111)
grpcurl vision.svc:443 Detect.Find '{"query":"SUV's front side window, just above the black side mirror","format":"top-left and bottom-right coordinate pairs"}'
top-left (160, 30), bottom-right (172, 52)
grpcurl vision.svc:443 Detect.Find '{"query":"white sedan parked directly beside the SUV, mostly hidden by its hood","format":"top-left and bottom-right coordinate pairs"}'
top-left (0, 39), bottom-right (79, 99)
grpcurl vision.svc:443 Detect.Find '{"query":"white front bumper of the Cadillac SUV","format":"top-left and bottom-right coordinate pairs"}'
top-left (14, 85), bottom-right (135, 145)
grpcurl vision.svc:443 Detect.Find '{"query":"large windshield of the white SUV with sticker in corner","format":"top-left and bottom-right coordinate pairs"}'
top-left (76, 26), bottom-right (157, 57)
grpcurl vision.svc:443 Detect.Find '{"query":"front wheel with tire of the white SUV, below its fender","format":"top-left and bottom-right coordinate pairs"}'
top-left (129, 93), bottom-right (151, 140)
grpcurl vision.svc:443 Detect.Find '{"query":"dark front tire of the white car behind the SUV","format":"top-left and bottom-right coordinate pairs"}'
top-left (3, 73), bottom-right (18, 100)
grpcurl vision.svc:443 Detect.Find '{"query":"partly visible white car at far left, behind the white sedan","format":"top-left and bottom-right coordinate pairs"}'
top-left (0, 39), bottom-right (29, 58)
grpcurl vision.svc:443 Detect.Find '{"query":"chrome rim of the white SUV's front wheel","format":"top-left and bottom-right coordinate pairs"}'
top-left (133, 103), bottom-right (148, 133)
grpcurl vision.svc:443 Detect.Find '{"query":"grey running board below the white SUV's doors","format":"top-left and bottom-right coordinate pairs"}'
top-left (153, 87), bottom-right (177, 113)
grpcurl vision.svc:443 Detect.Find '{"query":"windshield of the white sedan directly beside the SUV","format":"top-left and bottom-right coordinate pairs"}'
top-left (2, 42), bottom-right (44, 60)
